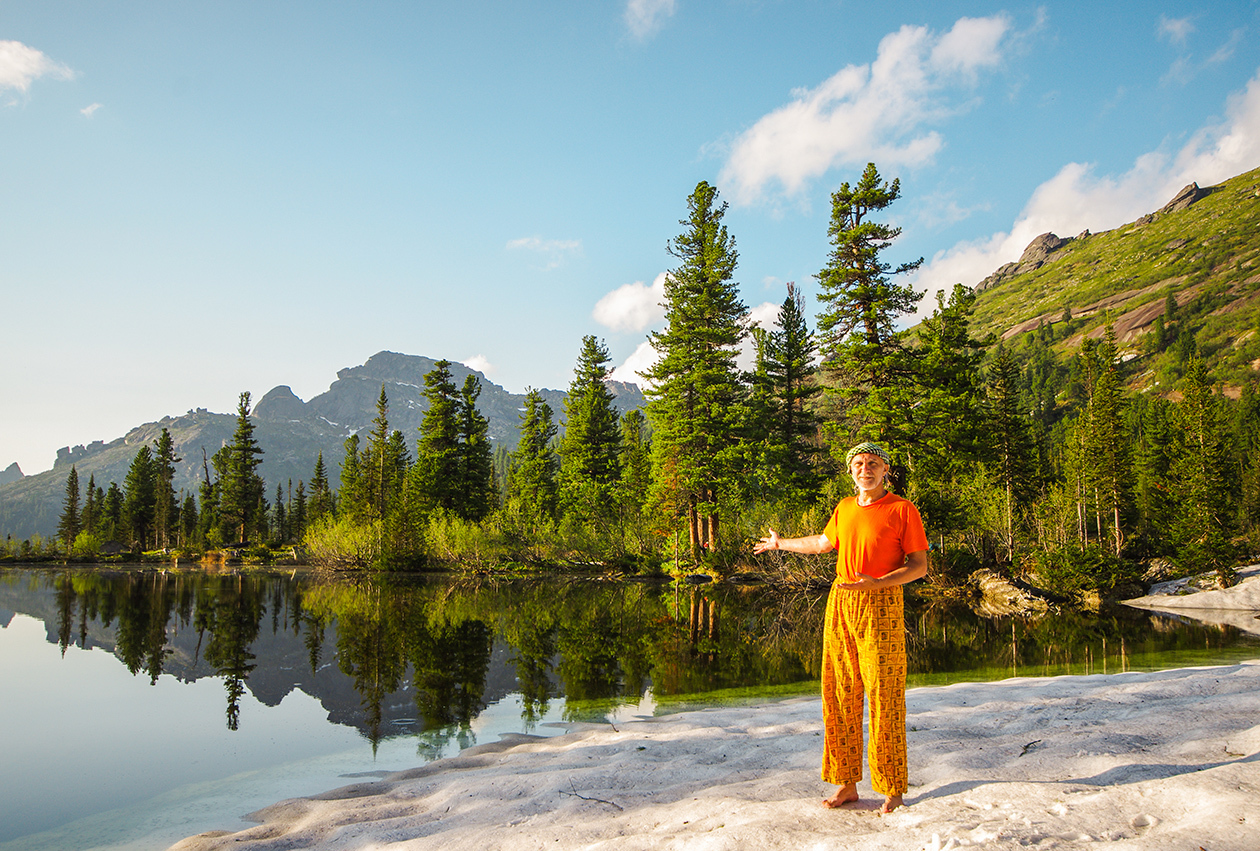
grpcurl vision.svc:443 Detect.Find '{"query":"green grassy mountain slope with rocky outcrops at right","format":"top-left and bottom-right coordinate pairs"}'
top-left (957, 163), bottom-right (1260, 393)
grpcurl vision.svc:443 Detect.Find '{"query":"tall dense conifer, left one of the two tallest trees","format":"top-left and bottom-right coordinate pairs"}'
top-left (643, 180), bottom-right (747, 561)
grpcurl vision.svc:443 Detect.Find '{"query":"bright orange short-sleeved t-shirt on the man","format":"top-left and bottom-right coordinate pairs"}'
top-left (823, 492), bottom-right (927, 582)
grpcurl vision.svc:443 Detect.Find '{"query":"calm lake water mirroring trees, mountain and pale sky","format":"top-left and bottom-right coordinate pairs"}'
top-left (0, 569), bottom-right (1260, 851)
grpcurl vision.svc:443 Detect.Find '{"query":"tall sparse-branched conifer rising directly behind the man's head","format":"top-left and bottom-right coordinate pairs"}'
top-left (818, 163), bottom-right (922, 453)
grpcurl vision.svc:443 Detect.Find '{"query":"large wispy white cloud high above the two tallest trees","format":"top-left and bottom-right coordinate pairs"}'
top-left (719, 15), bottom-right (1011, 204)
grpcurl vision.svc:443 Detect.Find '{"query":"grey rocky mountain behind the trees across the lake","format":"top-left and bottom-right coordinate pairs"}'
top-left (0, 352), bottom-right (644, 540)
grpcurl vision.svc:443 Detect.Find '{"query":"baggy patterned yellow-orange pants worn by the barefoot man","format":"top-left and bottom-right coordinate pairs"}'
top-left (823, 585), bottom-right (907, 796)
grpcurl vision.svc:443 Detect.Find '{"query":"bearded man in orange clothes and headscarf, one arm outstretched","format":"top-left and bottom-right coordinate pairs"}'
top-left (753, 443), bottom-right (927, 813)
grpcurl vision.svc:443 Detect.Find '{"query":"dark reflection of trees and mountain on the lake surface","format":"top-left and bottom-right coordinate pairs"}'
top-left (0, 570), bottom-right (1260, 754)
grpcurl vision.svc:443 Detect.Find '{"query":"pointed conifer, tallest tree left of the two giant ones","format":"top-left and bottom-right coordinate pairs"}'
top-left (559, 334), bottom-right (621, 521)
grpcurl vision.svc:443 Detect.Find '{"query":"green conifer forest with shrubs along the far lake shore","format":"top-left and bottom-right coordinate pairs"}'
top-left (12, 164), bottom-right (1260, 596)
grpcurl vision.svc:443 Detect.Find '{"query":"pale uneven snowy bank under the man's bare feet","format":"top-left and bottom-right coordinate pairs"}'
top-left (173, 661), bottom-right (1260, 851)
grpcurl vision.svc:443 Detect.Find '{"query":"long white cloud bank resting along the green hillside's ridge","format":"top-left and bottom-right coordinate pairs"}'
top-left (914, 64), bottom-right (1260, 320)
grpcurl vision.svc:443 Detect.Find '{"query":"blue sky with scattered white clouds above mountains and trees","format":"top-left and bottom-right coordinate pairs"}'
top-left (0, 0), bottom-right (1260, 475)
